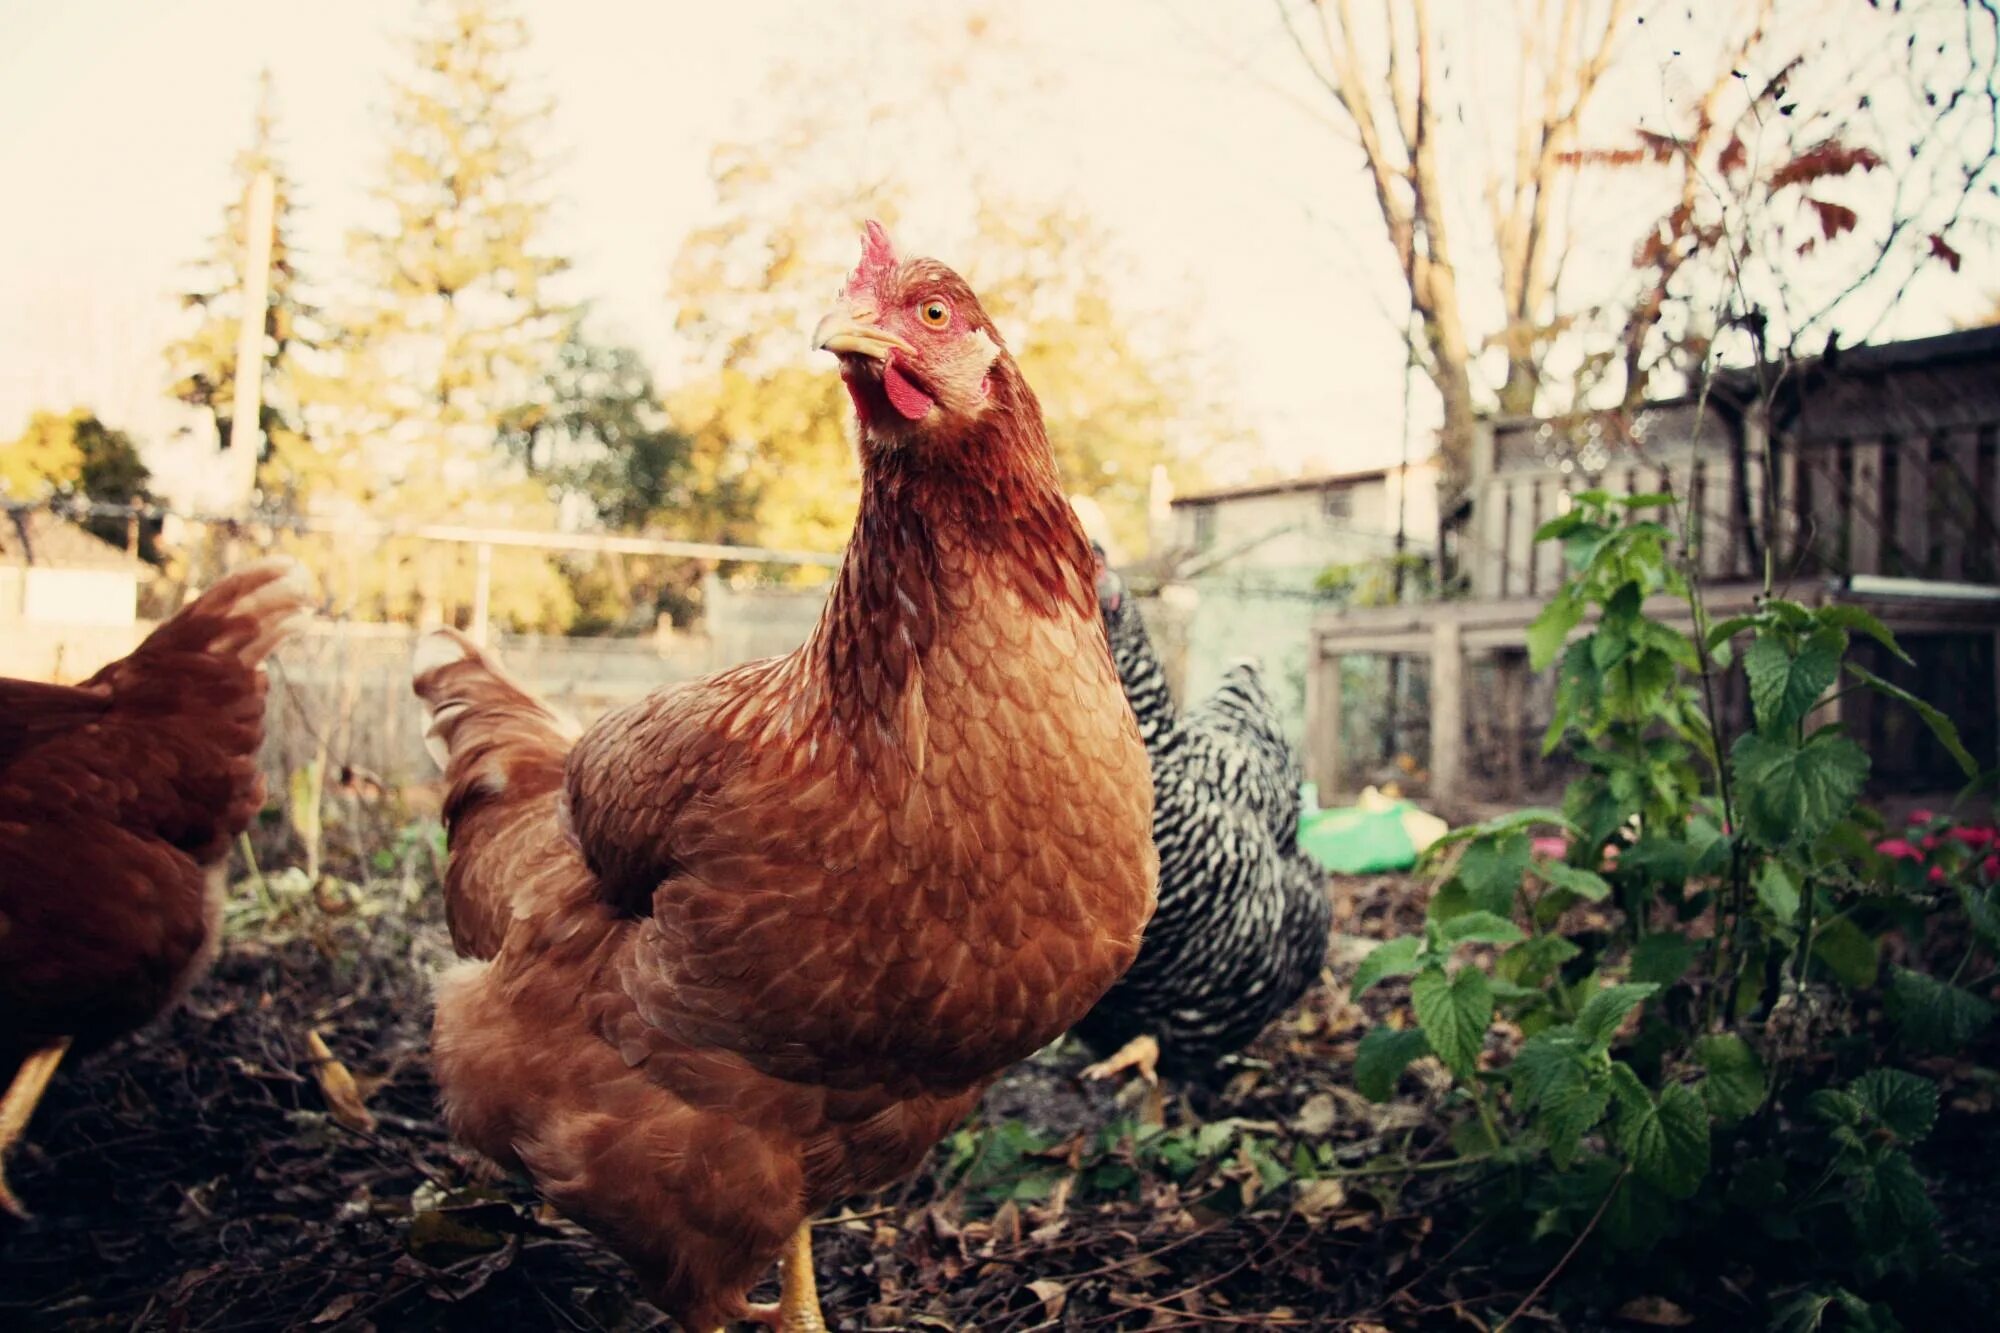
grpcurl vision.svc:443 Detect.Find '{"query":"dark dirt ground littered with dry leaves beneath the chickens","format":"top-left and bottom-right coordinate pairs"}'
top-left (0, 879), bottom-right (1990, 1333)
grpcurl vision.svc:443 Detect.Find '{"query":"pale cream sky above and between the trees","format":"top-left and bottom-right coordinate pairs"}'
top-left (0, 0), bottom-right (1994, 508)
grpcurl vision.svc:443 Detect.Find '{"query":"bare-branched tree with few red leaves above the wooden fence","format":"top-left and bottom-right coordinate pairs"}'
top-left (1274, 0), bottom-right (2000, 504)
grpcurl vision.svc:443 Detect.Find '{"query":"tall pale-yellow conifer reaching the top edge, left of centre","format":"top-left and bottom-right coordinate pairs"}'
top-left (316, 0), bottom-right (574, 628)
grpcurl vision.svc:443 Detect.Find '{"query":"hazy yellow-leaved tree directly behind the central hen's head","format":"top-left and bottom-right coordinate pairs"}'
top-left (668, 10), bottom-right (1242, 576)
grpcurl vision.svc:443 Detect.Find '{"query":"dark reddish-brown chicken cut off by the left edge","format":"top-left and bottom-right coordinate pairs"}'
top-left (0, 560), bottom-right (308, 1215)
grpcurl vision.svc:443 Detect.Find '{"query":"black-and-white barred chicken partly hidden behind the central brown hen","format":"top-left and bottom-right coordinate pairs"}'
top-left (1074, 544), bottom-right (1332, 1083)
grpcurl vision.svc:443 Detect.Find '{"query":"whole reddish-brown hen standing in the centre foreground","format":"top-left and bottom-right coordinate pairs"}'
top-left (416, 224), bottom-right (1156, 1333)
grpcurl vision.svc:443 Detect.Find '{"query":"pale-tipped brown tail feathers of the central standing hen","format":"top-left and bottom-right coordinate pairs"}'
top-left (410, 630), bottom-right (582, 959)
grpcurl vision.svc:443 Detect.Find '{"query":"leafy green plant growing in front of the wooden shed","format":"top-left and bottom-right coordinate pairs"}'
top-left (1352, 492), bottom-right (2000, 1327)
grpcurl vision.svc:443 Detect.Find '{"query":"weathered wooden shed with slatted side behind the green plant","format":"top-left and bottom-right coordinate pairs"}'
top-left (1308, 326), bottom-right (2000, 801)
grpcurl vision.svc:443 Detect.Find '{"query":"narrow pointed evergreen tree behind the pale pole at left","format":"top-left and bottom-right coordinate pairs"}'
top-left (166, 70), bottom-right (322, 500)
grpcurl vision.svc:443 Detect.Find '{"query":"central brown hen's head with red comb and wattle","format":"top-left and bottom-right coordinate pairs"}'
top-left (812, 222), bottom-right (1012, 444)
